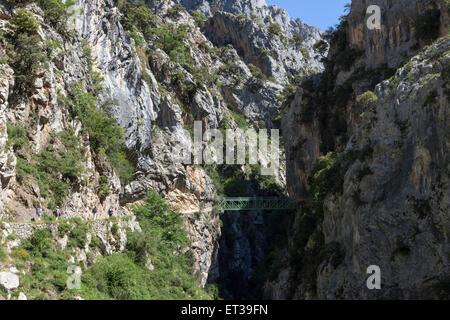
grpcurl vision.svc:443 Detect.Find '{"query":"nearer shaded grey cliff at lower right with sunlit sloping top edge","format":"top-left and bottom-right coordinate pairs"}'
top-left (312, 37), bottom-right (450, 299)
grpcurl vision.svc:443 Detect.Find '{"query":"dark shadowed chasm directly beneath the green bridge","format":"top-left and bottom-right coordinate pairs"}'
top-left (214, 211), bottom-right (292, 300)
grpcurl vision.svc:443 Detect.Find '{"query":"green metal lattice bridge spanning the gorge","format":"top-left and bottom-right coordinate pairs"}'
top-left (217, 197), bottom-right (299, 211)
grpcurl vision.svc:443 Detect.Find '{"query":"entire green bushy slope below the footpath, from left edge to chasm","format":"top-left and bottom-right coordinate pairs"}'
top-left (4, 191), bottom-right (213, 300)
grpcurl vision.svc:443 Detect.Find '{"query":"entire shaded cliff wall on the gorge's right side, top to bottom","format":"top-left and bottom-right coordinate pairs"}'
top-left (276, 1), bottom-right (450, 299)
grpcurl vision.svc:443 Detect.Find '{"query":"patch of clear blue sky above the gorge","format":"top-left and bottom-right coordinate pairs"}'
top-left (266, 0), bottom-right (351, 31)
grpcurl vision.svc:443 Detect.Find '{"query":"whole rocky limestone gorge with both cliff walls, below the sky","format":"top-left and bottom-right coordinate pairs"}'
top-left (0, 0), bottom-right (450, 299)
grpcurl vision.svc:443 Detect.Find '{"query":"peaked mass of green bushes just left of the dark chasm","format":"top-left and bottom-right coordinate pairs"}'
top-left (82, 191), bottom-right (211, 300)
